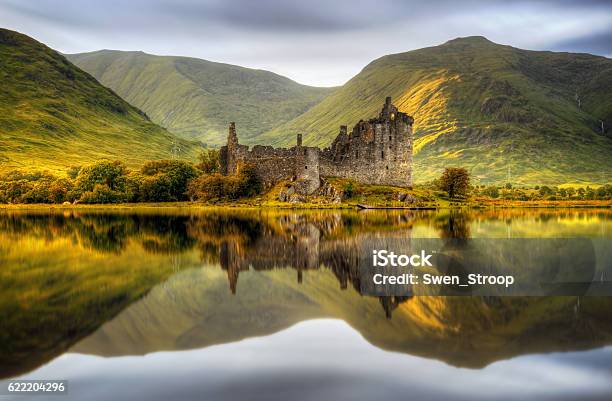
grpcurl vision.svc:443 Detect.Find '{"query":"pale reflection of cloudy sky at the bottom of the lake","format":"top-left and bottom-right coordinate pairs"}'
top-left (21, 320), bottom-right (612, 400)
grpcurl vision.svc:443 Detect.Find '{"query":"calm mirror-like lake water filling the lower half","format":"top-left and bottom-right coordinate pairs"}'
top-left (0, 209), bottom-right (612, 401)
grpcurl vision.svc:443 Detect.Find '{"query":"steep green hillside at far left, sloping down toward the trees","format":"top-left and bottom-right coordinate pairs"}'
top-left (0, 29), bottom-right (195, 171)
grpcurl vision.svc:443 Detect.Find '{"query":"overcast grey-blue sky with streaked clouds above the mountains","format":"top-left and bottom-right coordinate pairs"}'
top-left (0, 0), bottom-right (612, 86)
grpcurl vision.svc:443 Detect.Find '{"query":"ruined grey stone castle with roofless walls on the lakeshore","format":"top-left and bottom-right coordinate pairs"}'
top-left (220, 97), bottom-right (414, 195)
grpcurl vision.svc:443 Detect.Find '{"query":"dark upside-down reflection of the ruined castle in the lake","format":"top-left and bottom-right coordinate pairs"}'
top-left (212, 213), bottom-right (413, 317)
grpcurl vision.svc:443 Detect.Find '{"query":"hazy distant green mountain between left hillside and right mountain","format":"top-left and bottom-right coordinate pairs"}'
top-left (67, 50), bottom-right (333, 145)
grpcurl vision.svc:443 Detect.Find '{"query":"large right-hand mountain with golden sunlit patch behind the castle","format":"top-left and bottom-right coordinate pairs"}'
top-left (258, 37), bottom-right (612, 184)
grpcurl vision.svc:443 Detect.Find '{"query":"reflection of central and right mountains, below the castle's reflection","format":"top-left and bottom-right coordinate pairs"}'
top-left (72, 269), bottom-right (612, 367)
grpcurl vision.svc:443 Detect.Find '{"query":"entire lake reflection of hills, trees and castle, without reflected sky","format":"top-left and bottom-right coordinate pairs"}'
top-left (0, 210), bottom-right (610, 376)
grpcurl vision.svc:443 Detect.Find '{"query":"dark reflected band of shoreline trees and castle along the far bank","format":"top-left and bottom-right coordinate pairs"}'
top-left (0, 209), bottom-right (611, 314)
